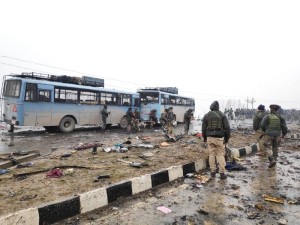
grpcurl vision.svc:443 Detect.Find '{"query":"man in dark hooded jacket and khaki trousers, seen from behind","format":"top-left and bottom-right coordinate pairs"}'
top-left (202, 101), bottom-right (230, 179)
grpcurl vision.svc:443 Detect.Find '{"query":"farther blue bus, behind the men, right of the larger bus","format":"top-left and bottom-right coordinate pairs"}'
top-left (138, 87), bottom-right (195, 123)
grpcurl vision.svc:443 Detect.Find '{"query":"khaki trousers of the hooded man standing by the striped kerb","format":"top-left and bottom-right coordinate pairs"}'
top-left (207, 137), bottom-right (226, 173)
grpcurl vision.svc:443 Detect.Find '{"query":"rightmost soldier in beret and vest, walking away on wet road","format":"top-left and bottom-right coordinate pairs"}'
top-left (261, 105), bottom-right (287, 168)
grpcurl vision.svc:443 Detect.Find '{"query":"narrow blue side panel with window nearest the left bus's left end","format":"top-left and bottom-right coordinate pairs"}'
top-left (23, 83), bottom-right (37, 126)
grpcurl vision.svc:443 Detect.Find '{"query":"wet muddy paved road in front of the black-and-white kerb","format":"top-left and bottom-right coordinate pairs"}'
top-left (57, 150), bottom-right (300, 225)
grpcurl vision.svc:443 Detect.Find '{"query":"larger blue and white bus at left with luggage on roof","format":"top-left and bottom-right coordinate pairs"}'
top-left (1, 73), bottom-right (139, 132)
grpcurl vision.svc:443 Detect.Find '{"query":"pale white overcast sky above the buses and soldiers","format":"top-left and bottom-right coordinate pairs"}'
top-left (0, 0), bottom-right (300, 116)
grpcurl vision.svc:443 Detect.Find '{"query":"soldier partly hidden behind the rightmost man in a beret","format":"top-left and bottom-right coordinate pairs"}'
top-left (253, 105), bottom-right (267, 150)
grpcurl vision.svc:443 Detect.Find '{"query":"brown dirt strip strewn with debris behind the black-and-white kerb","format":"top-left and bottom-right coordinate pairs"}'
top-left (0, 121), bottom-right (298, 216)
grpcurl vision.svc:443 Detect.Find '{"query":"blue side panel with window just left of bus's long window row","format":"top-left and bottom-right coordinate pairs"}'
top-left (36, 84), bottom-right (53, 126)
